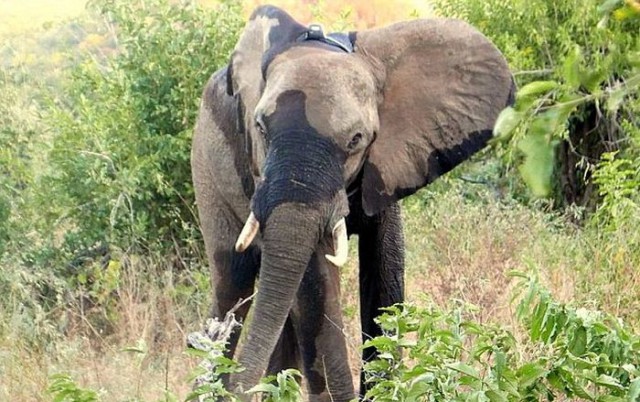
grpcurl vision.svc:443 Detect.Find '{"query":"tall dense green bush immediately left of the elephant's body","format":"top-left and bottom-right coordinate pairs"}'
top-left (47, 0), bottom-right (242, 251)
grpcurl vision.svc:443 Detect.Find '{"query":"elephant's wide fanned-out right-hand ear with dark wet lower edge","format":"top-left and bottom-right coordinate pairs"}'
top-left (354, 19), bottom-right (515, 215)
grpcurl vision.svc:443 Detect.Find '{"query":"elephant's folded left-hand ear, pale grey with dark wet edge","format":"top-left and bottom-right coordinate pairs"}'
top-left (227, 6), bottom-right (306, 116)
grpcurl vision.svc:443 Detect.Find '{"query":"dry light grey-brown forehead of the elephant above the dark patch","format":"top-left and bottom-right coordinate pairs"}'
top-left (259, 47), bottom-right (377, 133)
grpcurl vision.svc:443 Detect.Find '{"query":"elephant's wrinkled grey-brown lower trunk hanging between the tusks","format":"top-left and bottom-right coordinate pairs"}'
top-left (231, 203), bottom-right (327, 391)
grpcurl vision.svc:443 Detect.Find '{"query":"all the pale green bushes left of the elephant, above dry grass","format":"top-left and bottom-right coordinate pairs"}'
top-left (0, 0), bottom-right (243, 344)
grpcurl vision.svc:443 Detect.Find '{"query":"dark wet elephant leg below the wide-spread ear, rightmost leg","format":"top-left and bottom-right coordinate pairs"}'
top-left (358, 203), bottom-right (404, 395)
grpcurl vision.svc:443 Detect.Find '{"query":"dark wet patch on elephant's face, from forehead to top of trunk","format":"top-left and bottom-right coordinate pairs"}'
top-left (252, 91), bottom-right (346, 222)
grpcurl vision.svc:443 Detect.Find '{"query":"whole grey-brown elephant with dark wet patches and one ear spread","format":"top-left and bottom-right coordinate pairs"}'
top-left (191, 6), bottom-right (515, 401)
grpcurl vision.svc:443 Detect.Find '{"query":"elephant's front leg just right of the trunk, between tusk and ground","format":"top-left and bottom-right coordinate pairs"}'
top-left (292, 246), bottom-right (355, 402)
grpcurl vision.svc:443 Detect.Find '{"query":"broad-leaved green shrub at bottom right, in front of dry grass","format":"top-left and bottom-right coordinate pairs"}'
top-left (365, 274), bottom-right (640, 401)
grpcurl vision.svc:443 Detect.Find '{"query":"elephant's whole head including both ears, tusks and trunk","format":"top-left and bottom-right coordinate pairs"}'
top-left (227, 6), bottom-right (513, 394)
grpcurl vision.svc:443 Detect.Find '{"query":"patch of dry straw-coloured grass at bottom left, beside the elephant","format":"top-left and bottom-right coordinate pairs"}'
top-left (0, 256), bottom-right (208, 401)
